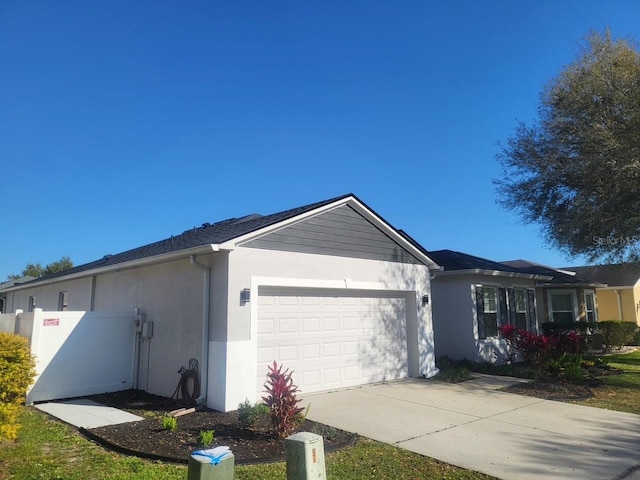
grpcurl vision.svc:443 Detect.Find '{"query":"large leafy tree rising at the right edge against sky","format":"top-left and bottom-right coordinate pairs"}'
top-left (495, 30), bottom-right (640, 260)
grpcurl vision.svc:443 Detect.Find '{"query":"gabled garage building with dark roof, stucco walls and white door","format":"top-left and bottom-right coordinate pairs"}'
top-left (3, 195), bottom-right (439, 411)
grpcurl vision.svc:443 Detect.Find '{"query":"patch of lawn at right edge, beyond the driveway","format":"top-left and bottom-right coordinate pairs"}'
top-left (579, 350), bottom-right (640, 415)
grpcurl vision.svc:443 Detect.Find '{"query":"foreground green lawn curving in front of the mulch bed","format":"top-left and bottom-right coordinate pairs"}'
top-left (0, 408), bottom-right (492, 480)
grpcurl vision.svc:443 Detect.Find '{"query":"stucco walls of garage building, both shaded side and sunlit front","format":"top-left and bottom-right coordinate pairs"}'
top-left (6, 247), bottom-right (437, 410)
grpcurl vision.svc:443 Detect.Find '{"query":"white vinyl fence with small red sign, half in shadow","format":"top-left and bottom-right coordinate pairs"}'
top-left (0, 308), bottom-right (136, 405)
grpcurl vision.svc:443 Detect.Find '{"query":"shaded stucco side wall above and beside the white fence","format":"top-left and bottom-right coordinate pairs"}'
top-left (4, 255), bottom-right (212, 396)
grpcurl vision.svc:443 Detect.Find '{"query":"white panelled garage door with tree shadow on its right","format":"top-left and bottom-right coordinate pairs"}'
top-left (258, 287), bottom-right (409, 393)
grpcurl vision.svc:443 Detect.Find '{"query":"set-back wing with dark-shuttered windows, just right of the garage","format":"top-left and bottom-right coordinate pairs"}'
top-left (428, 250), bottom-right (552, 362)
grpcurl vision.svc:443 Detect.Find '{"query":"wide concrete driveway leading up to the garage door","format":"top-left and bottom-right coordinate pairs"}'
top-left (304, 375), bottom-right (640, 480)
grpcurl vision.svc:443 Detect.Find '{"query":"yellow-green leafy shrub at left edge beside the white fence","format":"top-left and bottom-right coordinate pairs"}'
top-left (0, 332), bottom-right (35, 440)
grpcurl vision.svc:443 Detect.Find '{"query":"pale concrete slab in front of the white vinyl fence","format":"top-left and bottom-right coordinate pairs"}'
top-left (34, 398), bottom-right (142, 428)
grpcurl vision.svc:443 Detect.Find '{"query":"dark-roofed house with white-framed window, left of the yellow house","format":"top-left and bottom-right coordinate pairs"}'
top-left (501, 260), bottom-right (606, 324)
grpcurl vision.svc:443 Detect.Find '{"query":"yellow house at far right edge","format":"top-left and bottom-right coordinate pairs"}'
top-left (566, 262), bottom-right (640, 325)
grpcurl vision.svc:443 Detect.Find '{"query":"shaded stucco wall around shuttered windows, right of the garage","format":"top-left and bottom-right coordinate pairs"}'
top-left (432, 274), bottom-right (535, 362)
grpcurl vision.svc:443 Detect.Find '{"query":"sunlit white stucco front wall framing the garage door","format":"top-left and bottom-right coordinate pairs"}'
top-left (208, 248), bottom-right (436, 410)
